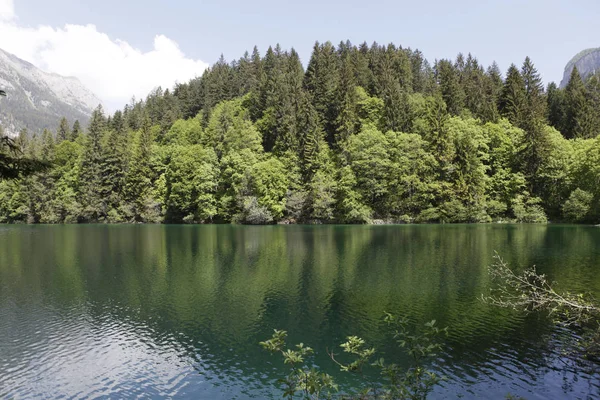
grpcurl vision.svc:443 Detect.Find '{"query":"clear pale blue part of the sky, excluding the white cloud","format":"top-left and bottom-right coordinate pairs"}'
top-left (0, 0), bottom-right (600, 108)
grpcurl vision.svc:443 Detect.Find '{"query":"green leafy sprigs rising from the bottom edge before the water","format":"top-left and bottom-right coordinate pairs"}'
top-left (260, 313), bottom-right (447, 400)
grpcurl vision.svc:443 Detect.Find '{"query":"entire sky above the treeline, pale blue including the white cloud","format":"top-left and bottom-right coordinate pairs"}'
top-left (0, 0), bottom-right (600, 111)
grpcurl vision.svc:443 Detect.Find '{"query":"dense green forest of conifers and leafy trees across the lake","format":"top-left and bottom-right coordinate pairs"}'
top-left (0, 42), bottom-right (600, 224)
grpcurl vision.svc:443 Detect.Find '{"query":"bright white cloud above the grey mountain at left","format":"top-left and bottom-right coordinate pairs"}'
top-left (0, 0), bottom-right (208, 110)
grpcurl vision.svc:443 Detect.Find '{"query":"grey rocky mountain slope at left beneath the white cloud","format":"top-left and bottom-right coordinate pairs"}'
top-left (0, 49), bottom-right (101, 135)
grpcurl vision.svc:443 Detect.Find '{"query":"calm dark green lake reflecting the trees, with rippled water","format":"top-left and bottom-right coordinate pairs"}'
top-left (0, 225), bottom-right (600, 399)
